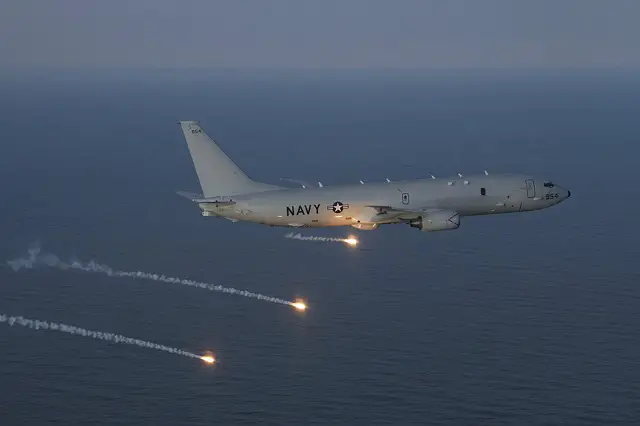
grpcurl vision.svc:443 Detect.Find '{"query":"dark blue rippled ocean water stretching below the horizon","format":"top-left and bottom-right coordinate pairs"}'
top-left (0, 72), bottom-right (640, 425)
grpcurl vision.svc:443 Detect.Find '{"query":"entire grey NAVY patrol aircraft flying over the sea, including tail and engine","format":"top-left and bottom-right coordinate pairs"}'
top-left (178, 121), bottom-right (571, 231)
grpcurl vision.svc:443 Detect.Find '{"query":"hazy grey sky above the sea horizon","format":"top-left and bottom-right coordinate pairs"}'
top-left (0, 0), bottom-right (640, 69)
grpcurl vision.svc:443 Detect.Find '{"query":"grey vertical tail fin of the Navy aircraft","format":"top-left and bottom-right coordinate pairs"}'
top-left (180, 121), bottom-right (278, 197)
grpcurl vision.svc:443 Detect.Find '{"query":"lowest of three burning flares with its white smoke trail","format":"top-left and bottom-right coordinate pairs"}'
top-left (0, 314), bottom-right (208, 361)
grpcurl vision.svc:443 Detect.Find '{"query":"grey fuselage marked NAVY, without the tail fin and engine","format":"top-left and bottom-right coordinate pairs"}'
top-left (200, 175), bottom-right (571, 229)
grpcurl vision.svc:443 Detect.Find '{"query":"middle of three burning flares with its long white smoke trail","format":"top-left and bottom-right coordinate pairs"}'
top-left (7, 243), bottom-right (299, 308)
